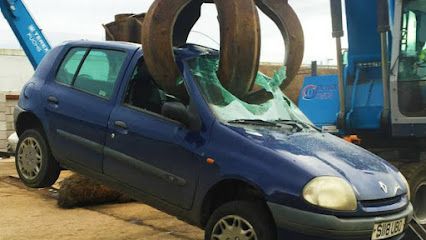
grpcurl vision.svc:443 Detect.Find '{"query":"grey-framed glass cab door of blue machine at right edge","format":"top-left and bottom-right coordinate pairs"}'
top-left (391, 0), bottom-right (426, 137)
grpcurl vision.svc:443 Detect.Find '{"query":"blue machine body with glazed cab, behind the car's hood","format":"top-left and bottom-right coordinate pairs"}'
top-left (299, 0), bottom-right (426, 139)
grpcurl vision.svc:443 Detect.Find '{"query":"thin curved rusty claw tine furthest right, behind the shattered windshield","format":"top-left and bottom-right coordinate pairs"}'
top-left (256, 0), bottom-right (305, 89)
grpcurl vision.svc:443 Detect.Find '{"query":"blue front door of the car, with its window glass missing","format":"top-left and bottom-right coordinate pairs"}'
top-left (104, 56), bottom-right (201, 209)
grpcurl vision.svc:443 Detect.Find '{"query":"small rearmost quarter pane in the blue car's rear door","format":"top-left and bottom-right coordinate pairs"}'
top-left (56, 48), bottom-right (87, 85)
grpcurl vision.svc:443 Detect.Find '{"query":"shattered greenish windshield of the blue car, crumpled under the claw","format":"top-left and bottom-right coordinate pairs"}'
top-left (189, 55), bottom-right (313, 128)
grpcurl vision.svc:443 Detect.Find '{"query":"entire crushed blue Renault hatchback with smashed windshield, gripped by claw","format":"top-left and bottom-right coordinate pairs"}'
top-left (14, 41), bottom-right (413, 240)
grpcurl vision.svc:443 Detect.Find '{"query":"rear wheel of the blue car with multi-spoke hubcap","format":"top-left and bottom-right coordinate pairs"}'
top-left (15, 129), bottom-right (60, 188)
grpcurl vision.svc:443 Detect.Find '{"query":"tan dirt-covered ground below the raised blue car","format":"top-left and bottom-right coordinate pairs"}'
top-left (0, 159), bottom-right (203, 240)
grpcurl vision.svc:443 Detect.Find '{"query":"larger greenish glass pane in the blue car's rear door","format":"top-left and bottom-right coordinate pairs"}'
top-left (73, 49), bottom-right (126, 99)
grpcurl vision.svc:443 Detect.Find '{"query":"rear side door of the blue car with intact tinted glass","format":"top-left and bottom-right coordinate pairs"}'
top-left (44, 47), bottom-right (127, 172)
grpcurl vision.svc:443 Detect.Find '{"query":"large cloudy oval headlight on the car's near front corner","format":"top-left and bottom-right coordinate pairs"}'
top-left (303, 176), bottom-right (357, 211)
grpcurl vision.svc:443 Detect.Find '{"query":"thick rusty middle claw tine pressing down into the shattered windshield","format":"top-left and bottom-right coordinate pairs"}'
top-left (214, 0), bottom-right (261, 98)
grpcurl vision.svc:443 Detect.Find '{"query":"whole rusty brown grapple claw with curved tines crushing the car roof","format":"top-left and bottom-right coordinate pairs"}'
top-left (104, 0), bottom-right (304, 101)
